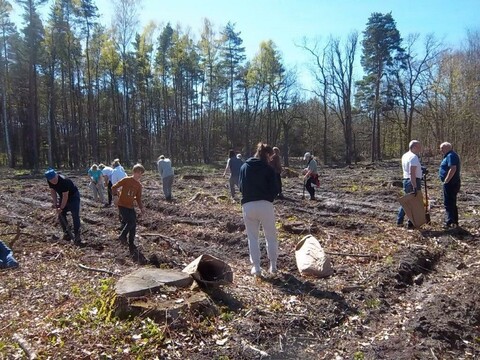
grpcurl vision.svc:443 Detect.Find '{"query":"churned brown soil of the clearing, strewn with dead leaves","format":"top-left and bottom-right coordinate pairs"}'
top-left (0, 162), bottom-right (480, 360)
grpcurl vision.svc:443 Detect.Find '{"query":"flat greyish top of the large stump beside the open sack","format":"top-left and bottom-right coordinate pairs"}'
top-left (115, 268), bottom-right (193, 297)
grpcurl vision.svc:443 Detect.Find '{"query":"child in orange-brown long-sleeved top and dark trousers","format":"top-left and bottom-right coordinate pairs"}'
top-left (112, 164), bottom-right (145, 252)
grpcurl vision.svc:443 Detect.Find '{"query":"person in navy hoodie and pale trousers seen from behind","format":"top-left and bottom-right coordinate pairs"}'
top-left (239, 142), bottom-right (279, 276)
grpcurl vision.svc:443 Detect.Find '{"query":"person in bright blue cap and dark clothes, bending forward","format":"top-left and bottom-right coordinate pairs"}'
top-left (45, 169), bottom-right (82, 246)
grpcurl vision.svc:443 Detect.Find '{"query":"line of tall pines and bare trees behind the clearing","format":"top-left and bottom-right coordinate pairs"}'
top-left (0, 0), bottom-right (480, 171)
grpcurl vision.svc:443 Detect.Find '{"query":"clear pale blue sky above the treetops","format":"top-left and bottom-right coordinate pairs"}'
top-left (12, 0), bottom-right (480, 89)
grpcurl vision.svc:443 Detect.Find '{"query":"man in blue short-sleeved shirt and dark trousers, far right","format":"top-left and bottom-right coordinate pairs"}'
top-left (438, 142), bottom-right (460, 228)
